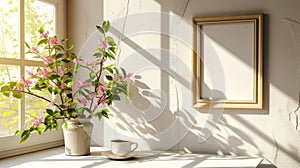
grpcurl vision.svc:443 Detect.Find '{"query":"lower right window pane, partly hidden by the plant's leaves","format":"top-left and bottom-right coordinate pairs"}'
top-left (25, 67), bottom-right (52, 128)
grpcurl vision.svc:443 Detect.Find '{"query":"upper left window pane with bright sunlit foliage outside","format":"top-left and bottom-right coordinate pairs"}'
top-left (0, 0), bottom-right (20, 58)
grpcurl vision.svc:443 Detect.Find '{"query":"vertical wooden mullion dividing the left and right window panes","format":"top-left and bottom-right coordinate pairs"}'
top-left (19, 0), bottom-right (25, 129)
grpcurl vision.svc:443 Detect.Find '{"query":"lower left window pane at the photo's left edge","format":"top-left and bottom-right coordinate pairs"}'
top-left (0, 64), bottom-right (20, 136)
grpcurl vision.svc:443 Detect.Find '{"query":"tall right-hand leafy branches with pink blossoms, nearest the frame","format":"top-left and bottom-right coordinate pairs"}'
top-left (76, 21), bottom-right (132, 120)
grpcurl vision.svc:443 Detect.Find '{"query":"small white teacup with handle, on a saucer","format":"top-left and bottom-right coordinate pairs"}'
top-left (111, 139), bottom-right (138, 156)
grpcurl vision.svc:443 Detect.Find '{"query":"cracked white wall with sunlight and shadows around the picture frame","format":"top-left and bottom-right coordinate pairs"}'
top-left (68, 0), bottom-right (300, 167)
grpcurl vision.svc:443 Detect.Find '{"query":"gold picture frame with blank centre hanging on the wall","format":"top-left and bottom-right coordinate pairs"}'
top-left (193, 14), bottom-right (263, 109)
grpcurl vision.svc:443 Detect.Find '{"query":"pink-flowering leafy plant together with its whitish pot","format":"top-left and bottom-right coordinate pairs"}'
top-left (0, 21), bottom-right (131, 155)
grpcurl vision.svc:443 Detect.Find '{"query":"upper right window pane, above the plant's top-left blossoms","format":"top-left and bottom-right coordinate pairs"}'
top-left (25, 0), bottom-right (55, 60)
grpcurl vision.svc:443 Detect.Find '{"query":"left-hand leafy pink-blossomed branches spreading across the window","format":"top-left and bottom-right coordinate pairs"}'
top-left (0, 27), bottom-right (78, 142)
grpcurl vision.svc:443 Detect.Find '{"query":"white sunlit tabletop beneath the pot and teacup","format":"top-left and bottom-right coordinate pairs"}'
top-left (0, 147), bottom-right (262, 168)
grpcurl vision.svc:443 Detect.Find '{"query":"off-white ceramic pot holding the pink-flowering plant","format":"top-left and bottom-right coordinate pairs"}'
top-left (62, 119), bottom-right (94, 156)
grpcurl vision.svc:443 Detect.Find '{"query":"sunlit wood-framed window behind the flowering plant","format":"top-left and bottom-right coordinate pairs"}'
top-left (0, 0), bottom-right (66, 157)
